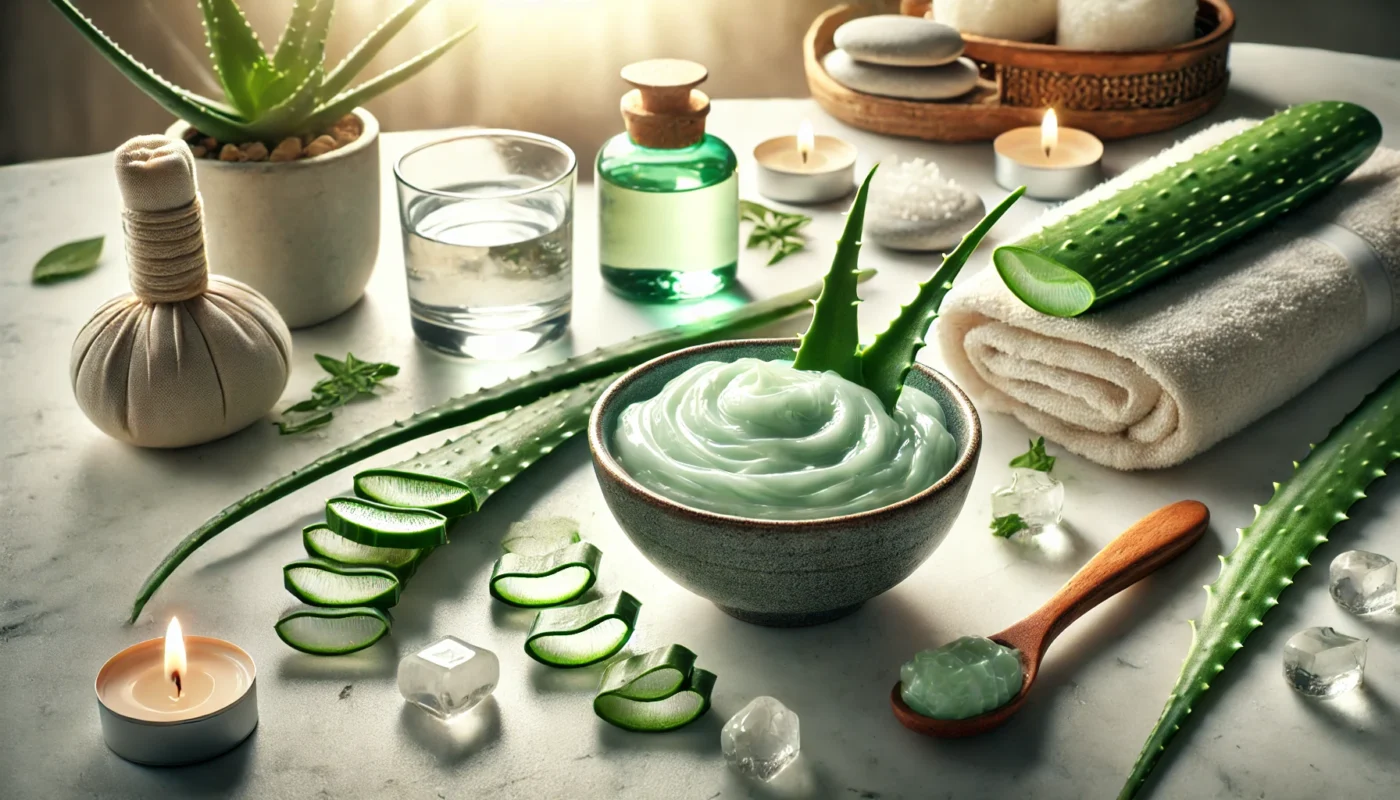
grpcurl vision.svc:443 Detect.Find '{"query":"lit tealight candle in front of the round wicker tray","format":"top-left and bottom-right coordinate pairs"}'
top-left (991, 109), bottom-right (1103, 200)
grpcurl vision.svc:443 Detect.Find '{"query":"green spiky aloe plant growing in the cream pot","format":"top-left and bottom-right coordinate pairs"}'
top-left (49, 0), bottom-right (472, 143)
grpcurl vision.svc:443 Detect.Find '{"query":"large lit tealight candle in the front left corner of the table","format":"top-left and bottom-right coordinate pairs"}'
top-left (95, 618), bottom-right (258, 766)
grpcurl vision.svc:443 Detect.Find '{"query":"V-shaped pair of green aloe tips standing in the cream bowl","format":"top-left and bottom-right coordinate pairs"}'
top-left (792, 165), bottom-right (1026, 412)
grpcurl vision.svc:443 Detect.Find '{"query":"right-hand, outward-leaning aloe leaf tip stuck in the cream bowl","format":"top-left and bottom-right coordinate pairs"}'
top-left (860, 186), bottom-right (1026, 412)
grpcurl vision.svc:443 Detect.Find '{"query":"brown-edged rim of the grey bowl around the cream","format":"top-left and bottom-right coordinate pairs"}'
top-left (588, 338), bottom-right (981, 531)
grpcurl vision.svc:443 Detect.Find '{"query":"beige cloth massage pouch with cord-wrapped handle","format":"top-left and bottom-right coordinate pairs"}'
top-left (70, 136), bottom-right (291, 447)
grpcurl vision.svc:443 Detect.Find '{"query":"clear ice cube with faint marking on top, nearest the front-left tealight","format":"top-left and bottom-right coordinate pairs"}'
top-left (399, 636), bottom-right (501, 720)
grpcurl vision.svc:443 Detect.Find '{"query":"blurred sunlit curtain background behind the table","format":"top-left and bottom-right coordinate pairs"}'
top-left (0, 0), bottom-right (1400, 165)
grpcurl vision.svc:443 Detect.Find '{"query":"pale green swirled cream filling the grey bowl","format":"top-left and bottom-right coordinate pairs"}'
top-left (613, 359), bottom-right (958, 520)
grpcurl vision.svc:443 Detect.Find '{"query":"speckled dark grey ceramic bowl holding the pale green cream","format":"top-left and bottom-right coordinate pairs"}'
top-left (588, 339), bottom-right (981, 626)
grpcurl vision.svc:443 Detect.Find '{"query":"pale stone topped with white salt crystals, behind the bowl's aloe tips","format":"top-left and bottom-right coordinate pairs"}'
top-left (865, 156), bottom-right (986, 252)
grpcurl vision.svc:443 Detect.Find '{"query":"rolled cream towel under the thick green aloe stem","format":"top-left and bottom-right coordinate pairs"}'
top-left (935, 120), bottom-right (1400, 469)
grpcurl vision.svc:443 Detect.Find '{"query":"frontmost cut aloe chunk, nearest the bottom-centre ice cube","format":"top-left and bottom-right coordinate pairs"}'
top-left (594, 644), bottom-right (715, 733)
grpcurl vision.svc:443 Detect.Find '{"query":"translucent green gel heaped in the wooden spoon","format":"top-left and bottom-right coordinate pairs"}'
top-left (899, 636), bottom-right (1021, 720)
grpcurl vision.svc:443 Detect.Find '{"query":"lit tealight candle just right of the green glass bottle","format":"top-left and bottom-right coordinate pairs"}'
top-left (753, 122), bottom-right (855, 203)
